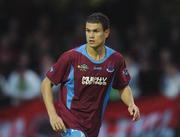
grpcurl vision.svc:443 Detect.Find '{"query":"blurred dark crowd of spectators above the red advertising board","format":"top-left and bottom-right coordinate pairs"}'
top-left (0, 0), bottom-right (180, 107)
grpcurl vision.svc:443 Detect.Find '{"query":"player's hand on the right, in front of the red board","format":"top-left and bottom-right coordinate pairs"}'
top-left (128, 104), bottom-right (140, 121)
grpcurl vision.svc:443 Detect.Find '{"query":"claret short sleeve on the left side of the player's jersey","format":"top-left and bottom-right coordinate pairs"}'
top-left (46, 52), bottom-right (71, 85)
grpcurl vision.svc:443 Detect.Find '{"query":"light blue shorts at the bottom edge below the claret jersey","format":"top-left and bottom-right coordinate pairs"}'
top-left (61, 129), bottom-right (86, 137)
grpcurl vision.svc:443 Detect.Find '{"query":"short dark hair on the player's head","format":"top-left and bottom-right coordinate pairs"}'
top-left (86, 12), bottom-right (110, 30)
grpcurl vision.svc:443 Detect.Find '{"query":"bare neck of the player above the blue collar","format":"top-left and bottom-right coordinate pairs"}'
top-left (86, 46), bottom-right (106, 60)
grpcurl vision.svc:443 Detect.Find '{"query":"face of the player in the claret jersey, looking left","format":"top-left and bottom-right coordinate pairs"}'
top-left (86, 22), bottom-right (109, 48)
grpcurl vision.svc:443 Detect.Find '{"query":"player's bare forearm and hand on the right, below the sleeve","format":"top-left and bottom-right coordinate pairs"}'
top-left (119, 86), bottom-right (140, 121)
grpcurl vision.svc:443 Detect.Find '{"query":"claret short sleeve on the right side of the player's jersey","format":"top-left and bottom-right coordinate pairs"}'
top-left (113, 57), bottom-right (131, 89)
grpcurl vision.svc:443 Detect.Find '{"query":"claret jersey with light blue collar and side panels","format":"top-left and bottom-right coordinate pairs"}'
top-left (47, 44), bottom-right (130, 137)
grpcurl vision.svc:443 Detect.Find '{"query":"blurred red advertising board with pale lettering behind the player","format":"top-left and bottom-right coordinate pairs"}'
top-left (0, 96), bottom-right (179, 137)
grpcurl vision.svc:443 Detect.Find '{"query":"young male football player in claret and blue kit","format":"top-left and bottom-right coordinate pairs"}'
top-left (41, 13), bottom-right (140, 137)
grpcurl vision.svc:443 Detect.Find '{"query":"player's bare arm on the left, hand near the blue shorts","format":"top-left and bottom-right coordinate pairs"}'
top-left (41, 77), bottom-right (66, 132)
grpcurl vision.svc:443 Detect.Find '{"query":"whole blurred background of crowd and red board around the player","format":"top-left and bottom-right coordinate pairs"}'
top-left (0, 0), bottom-right (180, 137)
